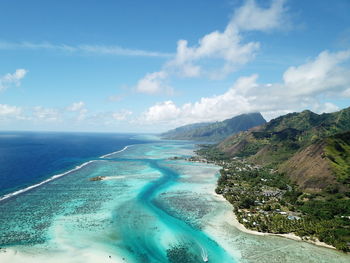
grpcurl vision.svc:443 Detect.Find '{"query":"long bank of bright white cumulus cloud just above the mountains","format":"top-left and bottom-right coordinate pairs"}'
top-left (140, 51), bottom-right (350, 127)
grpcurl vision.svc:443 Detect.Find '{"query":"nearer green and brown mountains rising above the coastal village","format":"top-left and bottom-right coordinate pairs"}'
top-left (217, 107), bottom-right (350, 192)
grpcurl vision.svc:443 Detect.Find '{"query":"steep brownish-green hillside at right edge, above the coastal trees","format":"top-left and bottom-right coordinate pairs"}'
top-left (280, 132), bottom-right (350, 191)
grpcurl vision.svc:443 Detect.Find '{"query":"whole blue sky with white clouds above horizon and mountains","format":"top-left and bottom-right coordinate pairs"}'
top-left (0, 0), bottom-right (350, 132)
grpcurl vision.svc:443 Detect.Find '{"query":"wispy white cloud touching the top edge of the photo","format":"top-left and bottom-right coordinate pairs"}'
top-left (232, 0), bottom-right (288, 31)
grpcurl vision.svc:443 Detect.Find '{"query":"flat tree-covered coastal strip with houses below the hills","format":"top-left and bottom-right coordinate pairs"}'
top-left (206, 158), bottom-right (350, 252)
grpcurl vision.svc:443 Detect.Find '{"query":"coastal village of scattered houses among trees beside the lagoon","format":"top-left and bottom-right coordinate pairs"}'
top-left (188, 156), bottom-right (302, 233)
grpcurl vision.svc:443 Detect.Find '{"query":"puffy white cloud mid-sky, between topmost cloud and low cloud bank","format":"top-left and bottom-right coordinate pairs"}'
top-left (165, 24), bottom-right (259, 78)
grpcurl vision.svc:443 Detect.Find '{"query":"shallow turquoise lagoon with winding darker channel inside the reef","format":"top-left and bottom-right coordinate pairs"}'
top-left (0, 141), bottom-right (350, 263)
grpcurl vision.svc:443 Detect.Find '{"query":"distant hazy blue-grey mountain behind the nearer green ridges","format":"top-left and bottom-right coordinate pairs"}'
top-left (161, 113), bottom-right (266, 141)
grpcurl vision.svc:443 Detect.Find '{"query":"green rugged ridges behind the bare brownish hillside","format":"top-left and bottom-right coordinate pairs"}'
top-left (218, 108), bottom-right (350, 168)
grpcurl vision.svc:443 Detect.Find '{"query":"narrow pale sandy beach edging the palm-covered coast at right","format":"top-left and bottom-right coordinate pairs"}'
top-left (212, 192), bottom-right (338, 251)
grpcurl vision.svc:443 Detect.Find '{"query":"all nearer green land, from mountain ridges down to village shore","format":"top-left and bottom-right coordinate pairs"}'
top-left (193, 108), bottom-right (350, 251)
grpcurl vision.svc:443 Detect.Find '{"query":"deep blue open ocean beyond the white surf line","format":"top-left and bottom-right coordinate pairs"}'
top-left (0, 132), bottom-right (145, 197)
